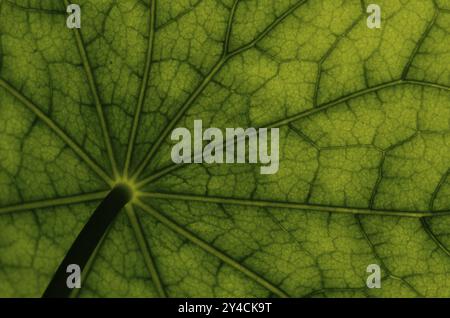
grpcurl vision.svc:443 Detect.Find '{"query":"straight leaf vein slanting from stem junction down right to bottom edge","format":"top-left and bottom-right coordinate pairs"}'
top-left (136, 201), bottom-right (289, 297)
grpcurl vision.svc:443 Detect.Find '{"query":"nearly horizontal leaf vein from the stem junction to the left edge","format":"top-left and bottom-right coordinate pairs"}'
top-left (0, 191), bottom-right (109, 215)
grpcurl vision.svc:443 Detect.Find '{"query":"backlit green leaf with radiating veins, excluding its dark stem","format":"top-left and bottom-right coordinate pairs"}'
top-left (0, 0), bottom-right (450, 297)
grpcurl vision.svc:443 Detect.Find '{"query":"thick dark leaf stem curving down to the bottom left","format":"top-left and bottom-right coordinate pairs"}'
top-left (42, 184), bottom-right (132, 298)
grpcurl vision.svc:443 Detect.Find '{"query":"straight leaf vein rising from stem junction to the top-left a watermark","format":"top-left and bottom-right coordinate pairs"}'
top-left (64, 0), bottom-right (118, 178)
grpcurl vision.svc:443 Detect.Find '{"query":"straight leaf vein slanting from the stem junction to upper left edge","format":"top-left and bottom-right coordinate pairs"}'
top-left (0, 78), bottom-right (112, 184)
